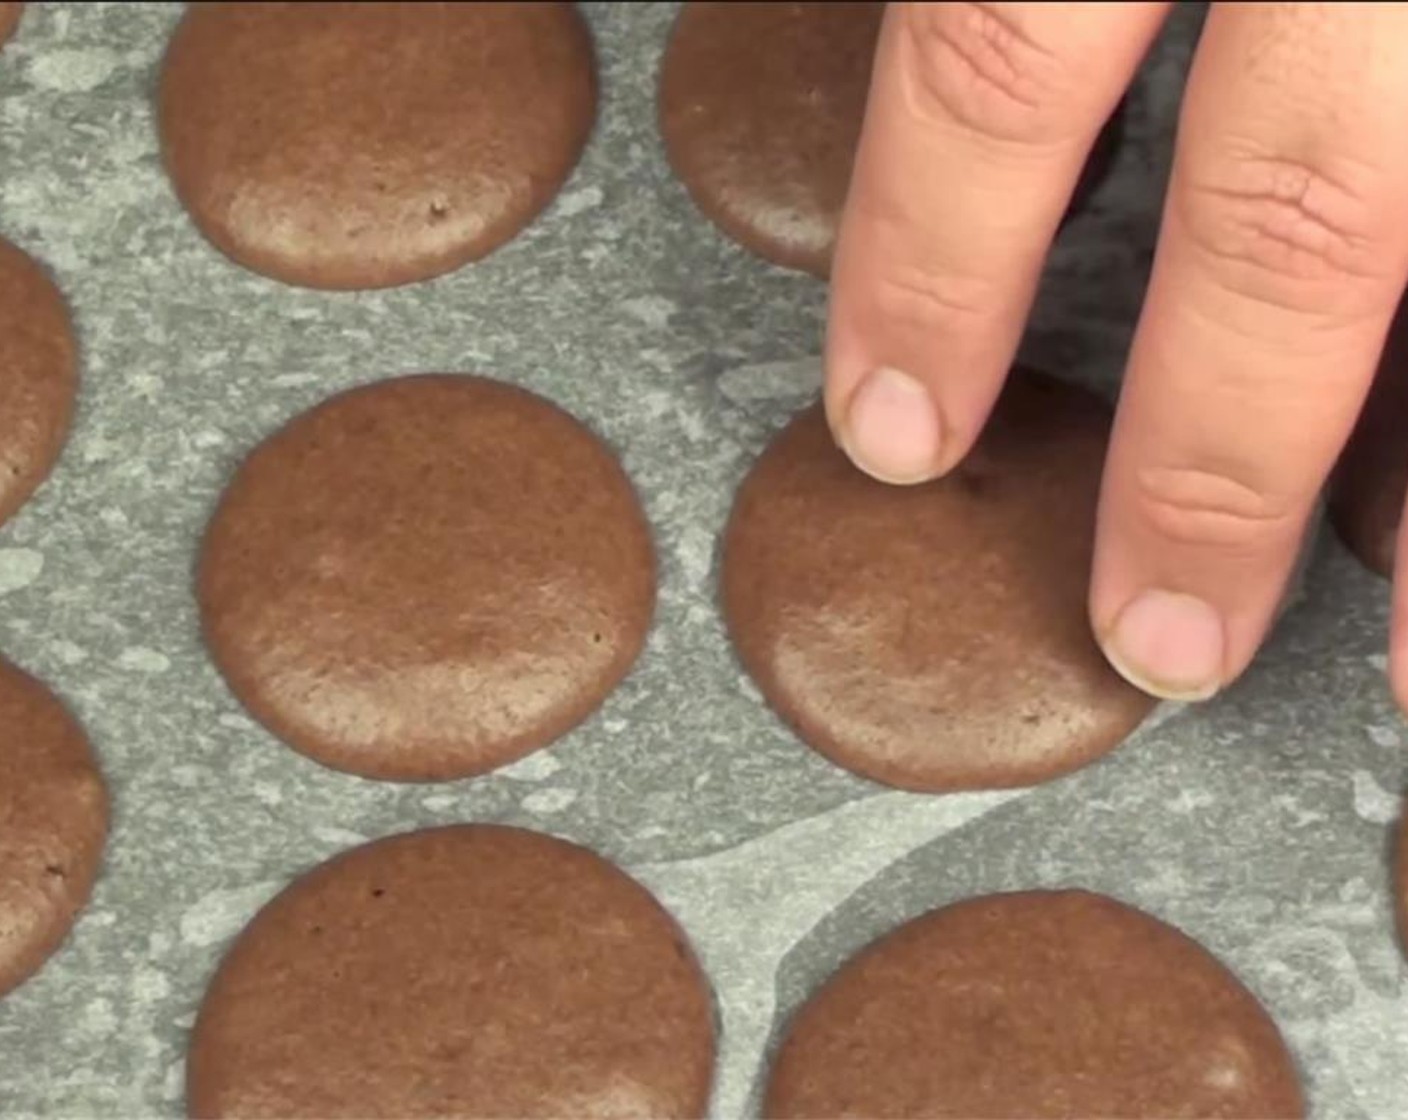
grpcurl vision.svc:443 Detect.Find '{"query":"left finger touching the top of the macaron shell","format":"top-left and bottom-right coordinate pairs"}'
top-left (826, 3), bottom-right (1169, 483)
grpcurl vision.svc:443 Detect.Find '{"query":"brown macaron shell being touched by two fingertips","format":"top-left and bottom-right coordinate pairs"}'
top-left (722, 369), bottom-right (1155, 792)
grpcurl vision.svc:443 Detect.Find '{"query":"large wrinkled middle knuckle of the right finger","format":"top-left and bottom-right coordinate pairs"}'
top-left (1184, 159), bottom-right (1378, 313)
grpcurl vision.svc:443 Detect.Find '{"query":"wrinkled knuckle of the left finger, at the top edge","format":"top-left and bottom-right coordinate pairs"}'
top-left (903, 3), bottom-right (1059, 142)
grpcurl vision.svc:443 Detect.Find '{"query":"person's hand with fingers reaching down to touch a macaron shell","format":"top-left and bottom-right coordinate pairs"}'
top-left (826, 3), bottom-right (1408, 702)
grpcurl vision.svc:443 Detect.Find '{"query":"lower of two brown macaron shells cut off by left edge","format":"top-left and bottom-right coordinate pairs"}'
top-left (0, 659), bottom-right (107, 996)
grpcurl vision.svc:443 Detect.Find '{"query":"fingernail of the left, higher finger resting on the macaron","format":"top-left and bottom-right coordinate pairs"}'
top-left (841, 366), bottom-right (943, 486)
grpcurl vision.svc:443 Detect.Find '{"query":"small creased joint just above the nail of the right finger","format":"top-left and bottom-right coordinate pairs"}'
top-left (1136, 466), bottom-right (1295, 549)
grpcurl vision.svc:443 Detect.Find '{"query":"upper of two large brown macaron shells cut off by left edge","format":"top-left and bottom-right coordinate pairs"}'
top-left (0, 238), bottom-right (77, 524)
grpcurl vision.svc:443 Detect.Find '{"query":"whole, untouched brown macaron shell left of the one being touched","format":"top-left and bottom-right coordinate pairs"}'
top-left (197, 375), bottom-right (655, 780)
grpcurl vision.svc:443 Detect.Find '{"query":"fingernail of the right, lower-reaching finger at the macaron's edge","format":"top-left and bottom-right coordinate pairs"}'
top-left (1101, 590), bottom-right (1224, 700)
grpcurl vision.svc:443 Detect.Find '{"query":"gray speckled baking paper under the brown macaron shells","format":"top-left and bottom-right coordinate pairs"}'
top-left (0, 3), bottom-right (1408, 1120)
